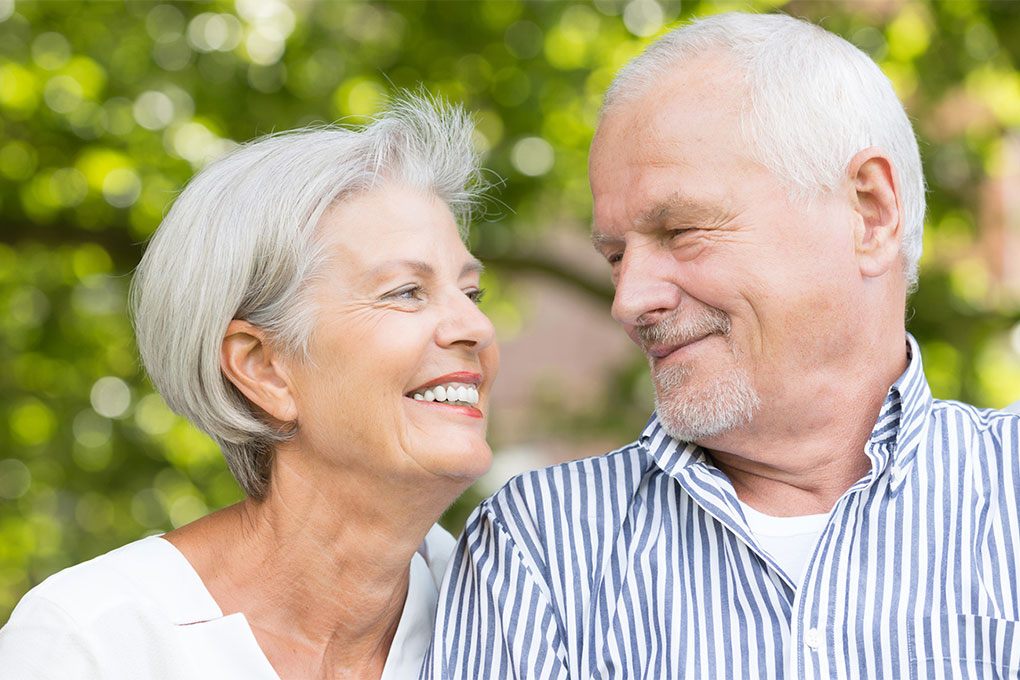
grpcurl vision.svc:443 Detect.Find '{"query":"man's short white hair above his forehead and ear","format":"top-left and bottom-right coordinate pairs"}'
top-left (602, 12), bottom-right (925, 290)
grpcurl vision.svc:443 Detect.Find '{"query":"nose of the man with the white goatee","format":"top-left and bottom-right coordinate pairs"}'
top-left (612, 245), bottom-right (682, 326)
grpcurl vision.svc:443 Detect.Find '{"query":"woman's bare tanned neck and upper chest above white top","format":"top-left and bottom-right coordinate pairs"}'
top-left (166, 452), bottom-right (462, 680)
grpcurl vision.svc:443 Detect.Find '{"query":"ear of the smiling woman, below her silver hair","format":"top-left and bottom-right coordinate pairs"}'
top-left (219, 319), bottom-right (298, 423)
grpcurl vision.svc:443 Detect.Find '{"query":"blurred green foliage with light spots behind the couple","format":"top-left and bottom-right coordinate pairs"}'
top-left (0, 0), bottom-right (1020, 622)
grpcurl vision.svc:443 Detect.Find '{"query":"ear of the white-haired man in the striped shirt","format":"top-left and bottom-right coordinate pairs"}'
top-left (847, 148), bottom-right (904, 276)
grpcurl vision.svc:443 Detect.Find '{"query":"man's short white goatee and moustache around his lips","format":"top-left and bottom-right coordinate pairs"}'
top-left (636, 307), bottom-right (761, 441)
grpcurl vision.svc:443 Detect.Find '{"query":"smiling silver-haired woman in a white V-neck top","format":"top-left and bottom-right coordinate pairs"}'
top-left (0, 97), bottom-right (498, 680)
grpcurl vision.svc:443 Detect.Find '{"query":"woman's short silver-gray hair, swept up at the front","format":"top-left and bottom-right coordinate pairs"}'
top-left (132, 95), bottom-right (483, 500)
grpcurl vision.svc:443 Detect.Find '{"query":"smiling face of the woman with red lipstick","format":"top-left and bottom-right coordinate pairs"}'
top-left (291, 185), bottom-right (499, 487)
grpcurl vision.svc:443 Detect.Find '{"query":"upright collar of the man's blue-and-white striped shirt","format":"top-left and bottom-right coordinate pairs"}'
top-left (639, 333), bottom-right (932, 491)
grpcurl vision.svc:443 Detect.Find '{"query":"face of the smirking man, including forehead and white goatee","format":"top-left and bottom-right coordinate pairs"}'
top-left (590, 58), bottom-right (860, 448)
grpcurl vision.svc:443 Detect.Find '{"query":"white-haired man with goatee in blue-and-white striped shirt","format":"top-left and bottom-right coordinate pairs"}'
top-left (423, 14), bottom-right (1020, 680)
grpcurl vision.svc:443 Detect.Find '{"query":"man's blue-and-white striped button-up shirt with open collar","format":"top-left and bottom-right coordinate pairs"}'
top-left (421, 336), bottom-right (1020, 680)
